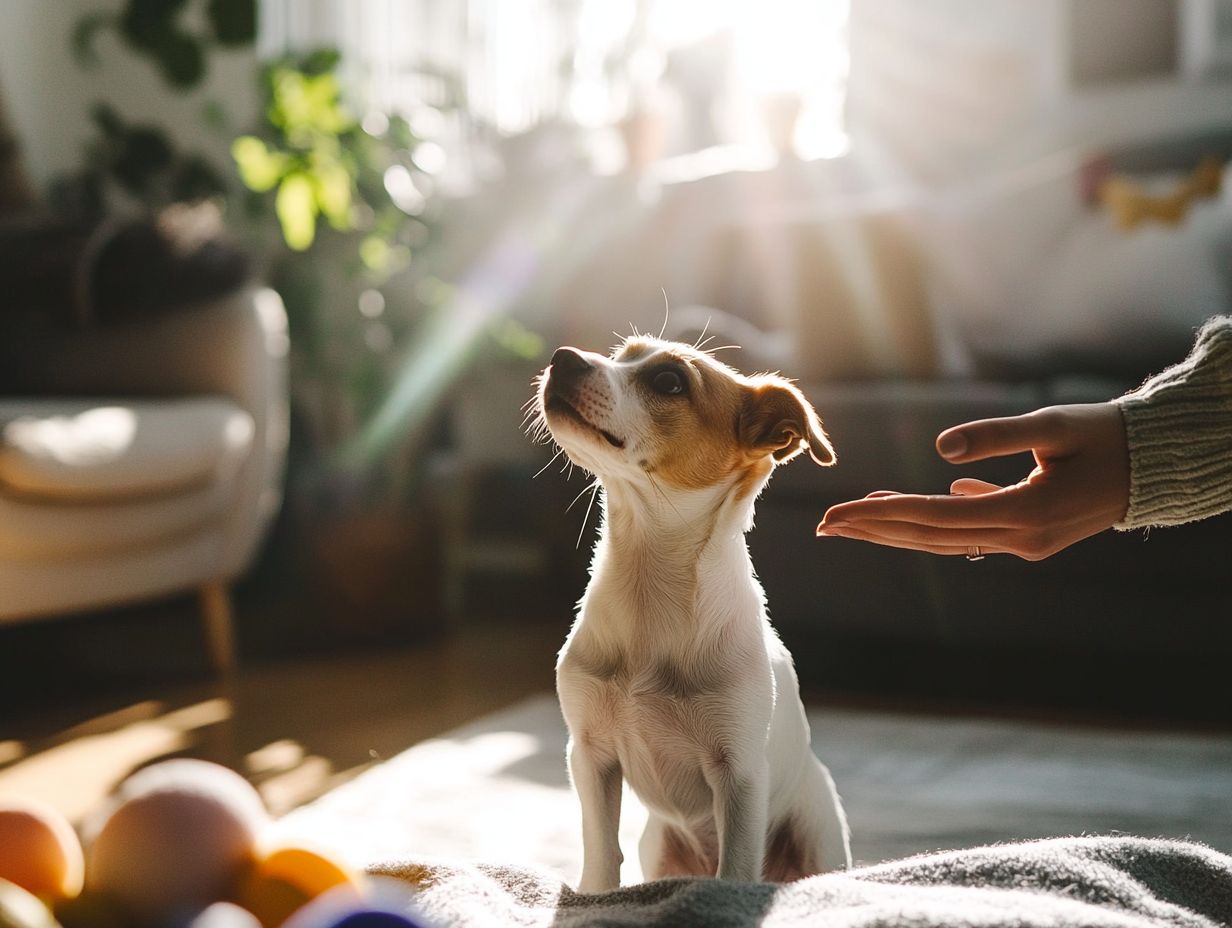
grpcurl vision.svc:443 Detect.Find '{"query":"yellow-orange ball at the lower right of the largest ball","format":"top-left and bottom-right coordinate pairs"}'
top-left (235, 844), bottom-right (361, 928)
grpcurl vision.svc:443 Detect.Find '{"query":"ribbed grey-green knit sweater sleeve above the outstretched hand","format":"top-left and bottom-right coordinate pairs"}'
top-left (1112, 317), bottom-right (1232, 530)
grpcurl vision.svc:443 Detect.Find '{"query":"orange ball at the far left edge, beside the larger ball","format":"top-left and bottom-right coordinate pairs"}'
top-left (0, 797), bottom-right (85, 901)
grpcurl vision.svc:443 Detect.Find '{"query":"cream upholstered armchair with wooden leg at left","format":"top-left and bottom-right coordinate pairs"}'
top-left (0, 288), bottom-right (287, 672)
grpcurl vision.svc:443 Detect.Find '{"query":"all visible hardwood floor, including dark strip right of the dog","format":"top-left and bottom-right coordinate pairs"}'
top-left (0, 604), bottom-right (1228, 838)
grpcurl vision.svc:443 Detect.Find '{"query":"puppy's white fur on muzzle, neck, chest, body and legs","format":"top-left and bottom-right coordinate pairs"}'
top-left (540, 342), bottom-right (850, 892)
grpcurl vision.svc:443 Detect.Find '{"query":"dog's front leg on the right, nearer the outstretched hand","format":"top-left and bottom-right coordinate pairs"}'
top-left (707, 759), bottom-right (770, 882)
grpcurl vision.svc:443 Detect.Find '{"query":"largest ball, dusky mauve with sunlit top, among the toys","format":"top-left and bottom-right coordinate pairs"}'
top-left (85, 759), bottom-right (269, 924)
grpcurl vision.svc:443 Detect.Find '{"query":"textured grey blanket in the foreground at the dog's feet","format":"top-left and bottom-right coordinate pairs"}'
top-left (371, 837), bottom-right (1232, 928)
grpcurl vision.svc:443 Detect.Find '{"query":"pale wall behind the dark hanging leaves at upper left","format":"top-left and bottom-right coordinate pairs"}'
top-left (0, 0), bottom-right (257, 190)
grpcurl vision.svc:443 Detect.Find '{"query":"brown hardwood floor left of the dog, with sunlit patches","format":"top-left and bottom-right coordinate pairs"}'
top-left (0, 622), bottom-right (564, 821)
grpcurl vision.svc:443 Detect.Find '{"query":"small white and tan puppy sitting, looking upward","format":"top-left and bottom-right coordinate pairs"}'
top-left (532, 336), bottom-right (851, 892)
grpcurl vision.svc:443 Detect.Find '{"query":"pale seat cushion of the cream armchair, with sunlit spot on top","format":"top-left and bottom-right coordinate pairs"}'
top-left (0, 397), bottom-right (253, 502)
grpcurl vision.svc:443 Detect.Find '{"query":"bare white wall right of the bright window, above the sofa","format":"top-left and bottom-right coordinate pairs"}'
top-left (848, 0), bottom-right (1232, 182)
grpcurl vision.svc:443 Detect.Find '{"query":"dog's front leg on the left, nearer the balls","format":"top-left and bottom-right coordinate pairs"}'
top-left (569, 738), bottom-right (625, 892)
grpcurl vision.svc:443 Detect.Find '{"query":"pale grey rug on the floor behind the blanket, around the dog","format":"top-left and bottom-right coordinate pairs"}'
top-left (281, 695), bottom-right (1232, 884)
